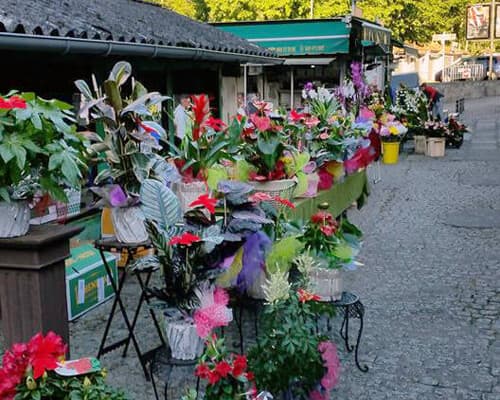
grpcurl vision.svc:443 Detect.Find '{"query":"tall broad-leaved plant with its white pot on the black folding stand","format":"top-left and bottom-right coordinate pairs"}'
top-left (75, 61), bottom-right (173, 243)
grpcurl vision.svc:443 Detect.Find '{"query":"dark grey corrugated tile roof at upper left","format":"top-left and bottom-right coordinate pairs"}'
top-left (0, 0), bottom-right (275, 57)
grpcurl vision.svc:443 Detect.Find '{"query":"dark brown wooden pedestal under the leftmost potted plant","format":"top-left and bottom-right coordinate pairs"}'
top-left (0, 225), bottom-right (83, 348)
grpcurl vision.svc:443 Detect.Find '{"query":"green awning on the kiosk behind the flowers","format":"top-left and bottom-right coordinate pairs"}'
top-left (214, 19), bottom-right (351, 56)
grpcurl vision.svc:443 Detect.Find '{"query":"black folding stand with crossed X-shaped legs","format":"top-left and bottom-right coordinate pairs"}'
top-left (95, 239), bottom-right (166, 380)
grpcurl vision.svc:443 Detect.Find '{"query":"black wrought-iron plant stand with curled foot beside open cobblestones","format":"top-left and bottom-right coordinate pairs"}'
top-left (328, 292), bottom-right (368, 372)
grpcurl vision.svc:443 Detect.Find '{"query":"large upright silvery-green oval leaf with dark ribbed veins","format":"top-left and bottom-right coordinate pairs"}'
top-left (141, 179), bottom-right (181, 230)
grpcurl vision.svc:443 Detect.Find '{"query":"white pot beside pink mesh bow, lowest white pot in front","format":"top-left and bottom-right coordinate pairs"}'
top-left (165, 316), bottom-right (203, 360)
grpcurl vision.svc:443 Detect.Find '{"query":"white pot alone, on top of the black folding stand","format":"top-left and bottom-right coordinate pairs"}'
top-left (111, 206), bottom-right (149, 243)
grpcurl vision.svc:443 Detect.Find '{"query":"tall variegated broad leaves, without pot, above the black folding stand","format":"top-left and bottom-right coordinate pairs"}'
top-left (75, 61), bottom-right (171, 200)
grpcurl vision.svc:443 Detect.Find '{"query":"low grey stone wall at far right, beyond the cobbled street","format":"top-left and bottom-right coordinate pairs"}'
top-left (431, 80), bottom-right (500, 103)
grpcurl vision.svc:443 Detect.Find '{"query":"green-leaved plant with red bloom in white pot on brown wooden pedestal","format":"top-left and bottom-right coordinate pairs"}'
top-left (0, 91), bottom-right (86, 238)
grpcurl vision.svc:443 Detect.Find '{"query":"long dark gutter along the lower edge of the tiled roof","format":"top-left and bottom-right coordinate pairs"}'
top-left (0, 33), bottom-right (284, 64)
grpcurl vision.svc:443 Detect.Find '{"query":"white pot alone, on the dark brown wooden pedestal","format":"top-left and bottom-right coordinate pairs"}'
top-left (0, 200), bottom-right (31, 238)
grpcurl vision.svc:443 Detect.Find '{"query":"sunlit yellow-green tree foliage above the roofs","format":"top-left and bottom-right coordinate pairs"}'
top-left (150, 0), bottom-right (490, 43)
